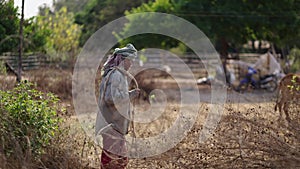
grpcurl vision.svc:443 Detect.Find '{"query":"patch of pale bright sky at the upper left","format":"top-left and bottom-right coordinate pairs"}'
top-left (14, 0), bottom-right (53, 19)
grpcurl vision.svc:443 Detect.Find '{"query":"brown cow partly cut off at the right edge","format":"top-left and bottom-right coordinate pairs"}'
top-left (275, 74), bottom-right (300, 122)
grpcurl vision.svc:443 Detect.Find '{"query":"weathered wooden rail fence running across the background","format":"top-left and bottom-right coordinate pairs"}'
top-left (0, 51), bottom-right (268, 81)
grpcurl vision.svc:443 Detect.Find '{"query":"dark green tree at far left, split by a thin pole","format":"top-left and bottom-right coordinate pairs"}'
top-left (0, 0), bottom-right (48, 53)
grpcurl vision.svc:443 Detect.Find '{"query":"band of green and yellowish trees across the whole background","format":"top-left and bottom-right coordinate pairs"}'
top-left (0, 0), bottom-right (300, 70)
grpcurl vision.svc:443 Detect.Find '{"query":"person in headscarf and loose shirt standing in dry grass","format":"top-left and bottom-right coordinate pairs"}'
top-left (95, 44), bottom-right (140, 169)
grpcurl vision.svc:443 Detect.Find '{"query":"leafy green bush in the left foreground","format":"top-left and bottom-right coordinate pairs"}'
top-left (0, 83), bottom-right (60, 156)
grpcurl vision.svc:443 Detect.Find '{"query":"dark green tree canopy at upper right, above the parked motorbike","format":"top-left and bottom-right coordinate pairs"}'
top-left (124, 0), bottom-right (300, 52)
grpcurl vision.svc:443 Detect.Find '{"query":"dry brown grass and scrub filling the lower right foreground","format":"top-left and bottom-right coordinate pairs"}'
top-left (128, 99), bottom-right (300, 169)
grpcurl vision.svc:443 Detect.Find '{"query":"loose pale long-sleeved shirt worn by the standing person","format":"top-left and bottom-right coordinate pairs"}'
top-left (95, 69), bottom-right (132, 135)
